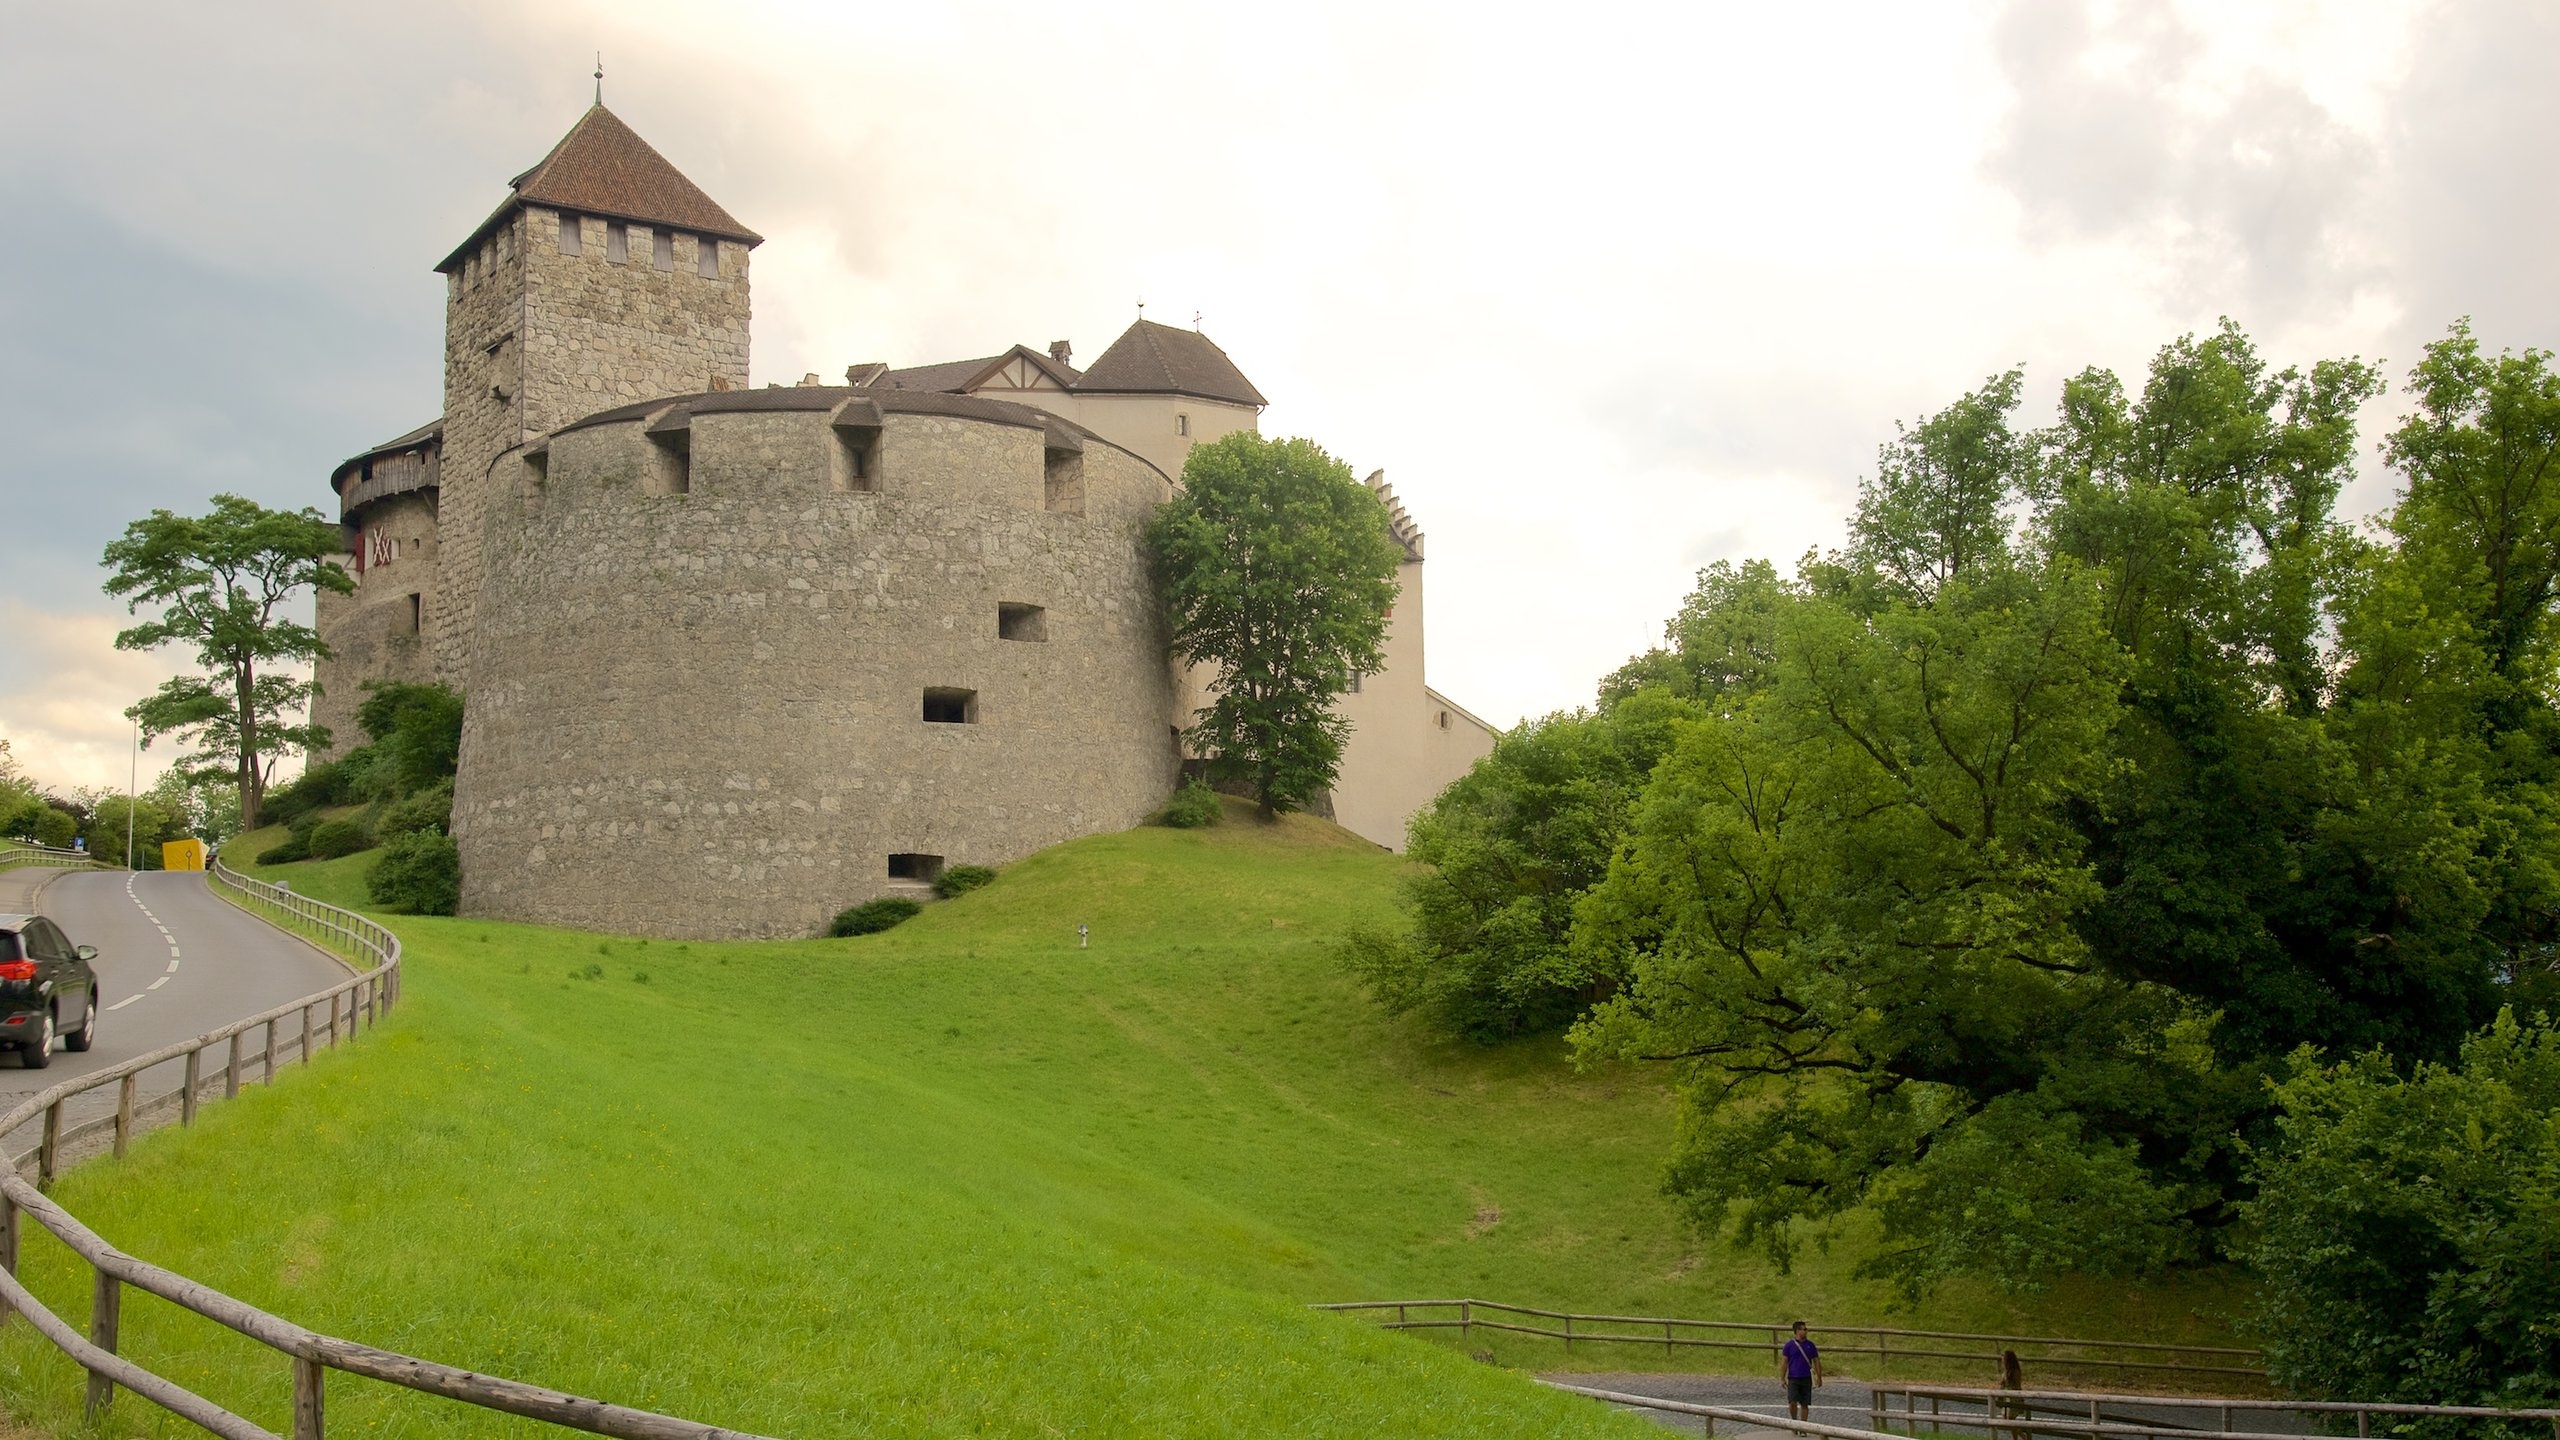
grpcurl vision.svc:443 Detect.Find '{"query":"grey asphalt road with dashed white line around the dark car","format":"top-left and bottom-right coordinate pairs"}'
top-left (0, 869), bottom-right (348, 1153)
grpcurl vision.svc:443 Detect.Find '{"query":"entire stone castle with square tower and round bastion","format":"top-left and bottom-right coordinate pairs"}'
top-left (312, 102), bottom-right (1492, 938)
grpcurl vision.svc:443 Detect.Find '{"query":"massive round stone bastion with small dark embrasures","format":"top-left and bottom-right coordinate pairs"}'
top-left (453, 384), bottom-right (1180, 938)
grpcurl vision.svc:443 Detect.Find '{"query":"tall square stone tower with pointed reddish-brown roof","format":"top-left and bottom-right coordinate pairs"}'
top-left (419, 102), bottom-right (763, 681)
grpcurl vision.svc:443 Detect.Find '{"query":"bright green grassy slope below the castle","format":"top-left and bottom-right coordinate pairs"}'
top-left (0, 799), bottom-right (2237, 1437)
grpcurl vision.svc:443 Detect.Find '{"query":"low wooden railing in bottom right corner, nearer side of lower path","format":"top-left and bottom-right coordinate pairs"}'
top-left (1869, 1384), bottom-right (2560, 1440)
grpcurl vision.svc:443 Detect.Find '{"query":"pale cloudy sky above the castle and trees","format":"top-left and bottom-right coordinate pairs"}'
top-left (0, 0), bottom-right (2560, 784)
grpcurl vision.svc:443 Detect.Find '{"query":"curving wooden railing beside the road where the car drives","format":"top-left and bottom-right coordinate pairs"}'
top-left (0, 858), bottom-right (760, 1440)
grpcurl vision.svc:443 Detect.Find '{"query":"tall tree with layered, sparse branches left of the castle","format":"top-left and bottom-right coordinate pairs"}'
top-left (102, 495), bottom-right (356, 828)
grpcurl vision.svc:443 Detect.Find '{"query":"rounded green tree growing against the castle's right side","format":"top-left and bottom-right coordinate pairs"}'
top-left (1147, 430), bottom-right (1403, 817)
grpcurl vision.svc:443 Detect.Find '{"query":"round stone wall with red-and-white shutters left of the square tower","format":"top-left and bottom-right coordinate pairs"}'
top-left (312, 492), bottom-right (443, 761)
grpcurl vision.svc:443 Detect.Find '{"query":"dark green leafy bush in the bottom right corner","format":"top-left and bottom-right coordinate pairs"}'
top-left (2248, 1012), bottom-right (2560, 1404)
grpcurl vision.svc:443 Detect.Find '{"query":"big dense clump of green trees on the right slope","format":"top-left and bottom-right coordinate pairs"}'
top-left (1352, 325), bottom-right (2560, 1322)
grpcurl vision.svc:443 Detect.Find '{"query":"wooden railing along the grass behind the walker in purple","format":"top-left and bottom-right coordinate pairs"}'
top-left (1316, 1299), bottom-right (2266, 1386)
